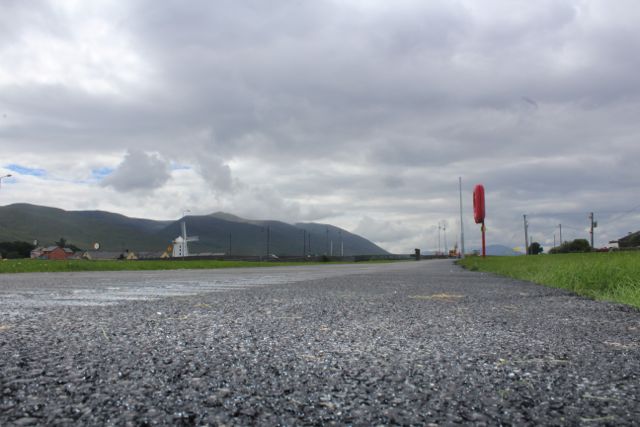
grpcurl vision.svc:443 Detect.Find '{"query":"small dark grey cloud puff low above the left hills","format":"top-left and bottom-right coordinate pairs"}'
top-left (101, 150), bottom-right (170, 192)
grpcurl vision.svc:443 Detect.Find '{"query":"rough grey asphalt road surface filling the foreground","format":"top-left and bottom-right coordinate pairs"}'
top-left (0, 261), bottom-right (640, 426)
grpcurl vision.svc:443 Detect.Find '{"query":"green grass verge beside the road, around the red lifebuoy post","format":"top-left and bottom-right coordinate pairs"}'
top-left (459, 252), bottom-right (640, 308)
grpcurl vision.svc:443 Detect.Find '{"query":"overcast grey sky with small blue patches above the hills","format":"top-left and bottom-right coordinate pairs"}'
top-left (0, 0), bottom-right (640, 253)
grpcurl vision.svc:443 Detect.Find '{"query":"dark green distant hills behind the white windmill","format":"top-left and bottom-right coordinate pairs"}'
top-left (0, 203), bottom-right (388, 255)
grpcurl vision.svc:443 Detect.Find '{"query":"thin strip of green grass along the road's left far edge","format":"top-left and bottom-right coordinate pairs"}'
top-left (0, 259), bottom-right (398, 274)
